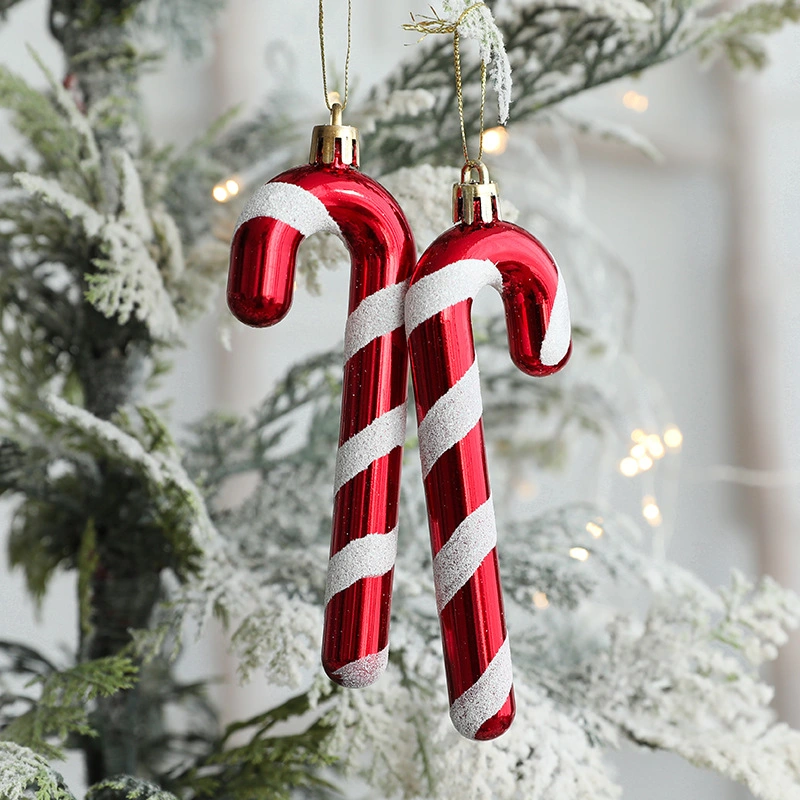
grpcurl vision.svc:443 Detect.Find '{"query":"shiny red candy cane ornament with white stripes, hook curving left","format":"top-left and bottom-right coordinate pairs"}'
top-left (228, 104), bottom-right (416, 687)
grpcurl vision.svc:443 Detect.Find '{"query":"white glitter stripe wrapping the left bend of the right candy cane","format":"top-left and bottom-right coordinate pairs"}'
top-left (406, 258), bottom-right (503, 336)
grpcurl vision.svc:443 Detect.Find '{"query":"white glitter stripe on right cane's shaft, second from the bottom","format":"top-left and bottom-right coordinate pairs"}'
top-left (433, 497), bottom-right (497, 614)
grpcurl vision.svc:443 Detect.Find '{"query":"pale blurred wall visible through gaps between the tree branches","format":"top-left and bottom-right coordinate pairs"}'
top-left (0, 0), bottom-right (800, 800)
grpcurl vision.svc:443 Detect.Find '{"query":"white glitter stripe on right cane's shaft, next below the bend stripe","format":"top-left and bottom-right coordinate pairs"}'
top-left (419, 359), bottom-right (483, 478)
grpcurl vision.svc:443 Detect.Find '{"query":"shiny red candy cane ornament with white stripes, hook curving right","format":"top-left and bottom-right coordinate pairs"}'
top-left (406, 162), bottom-right (572, 739)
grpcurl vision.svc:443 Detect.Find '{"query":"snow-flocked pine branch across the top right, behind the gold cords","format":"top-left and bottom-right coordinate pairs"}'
top-left (365, 0), bottom-right (800, 172)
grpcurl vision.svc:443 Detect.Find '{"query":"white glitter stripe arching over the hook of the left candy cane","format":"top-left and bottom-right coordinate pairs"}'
top-left (234, 182), bottom-right (342, 236)
